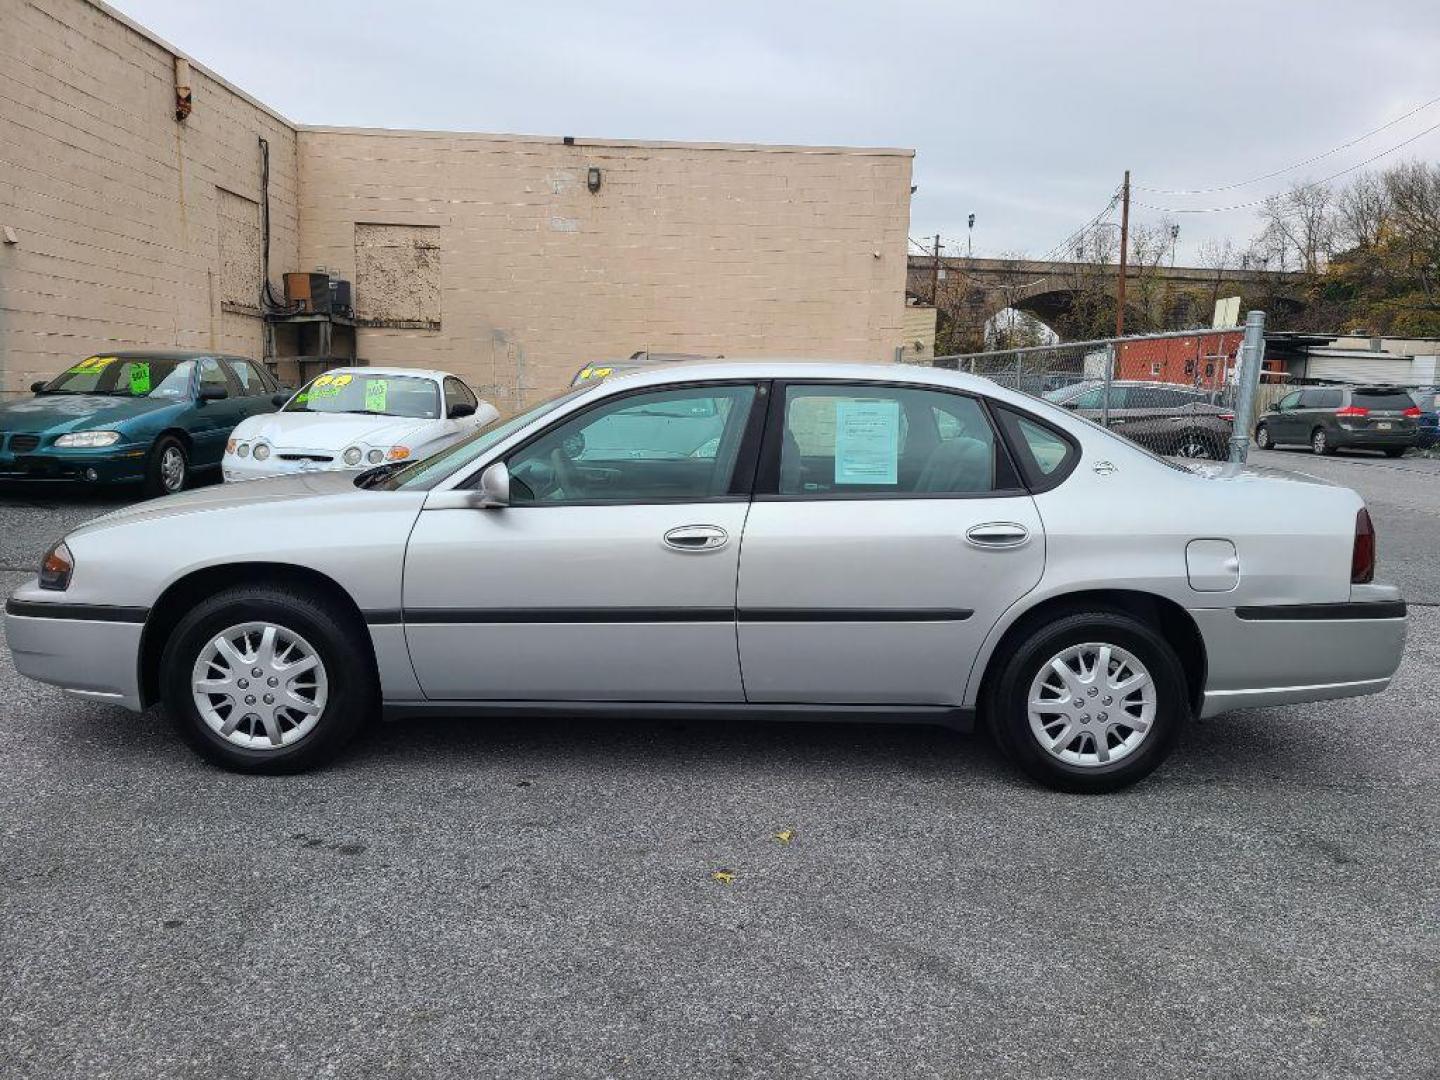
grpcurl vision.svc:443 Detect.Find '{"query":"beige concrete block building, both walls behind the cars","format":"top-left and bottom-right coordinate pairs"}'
top-left (0, 0), bottom-right (913, 410)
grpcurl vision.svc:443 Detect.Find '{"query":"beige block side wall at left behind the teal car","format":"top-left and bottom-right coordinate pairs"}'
top-left (0, 0), bottom-right (298, 392)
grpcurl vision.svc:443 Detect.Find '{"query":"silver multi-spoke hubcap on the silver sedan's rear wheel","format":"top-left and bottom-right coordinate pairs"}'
top-left (1030, 642), bottom-right (1155, 769)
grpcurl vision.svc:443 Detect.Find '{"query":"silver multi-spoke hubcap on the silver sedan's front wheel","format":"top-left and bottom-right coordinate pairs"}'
top-left (190, 622), bottom-right (330, 750)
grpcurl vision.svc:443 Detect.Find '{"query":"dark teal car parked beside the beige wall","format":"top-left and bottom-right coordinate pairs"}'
top-left (0, 350), bottom-right (279, 495)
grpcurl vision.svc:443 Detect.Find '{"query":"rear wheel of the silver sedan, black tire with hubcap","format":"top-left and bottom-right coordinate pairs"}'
top-left (986, 611), bottom-right (1191, 793)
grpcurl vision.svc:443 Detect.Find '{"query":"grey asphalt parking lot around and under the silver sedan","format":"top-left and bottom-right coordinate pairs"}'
top-left (0, 452), bottom-right (1440, 1080)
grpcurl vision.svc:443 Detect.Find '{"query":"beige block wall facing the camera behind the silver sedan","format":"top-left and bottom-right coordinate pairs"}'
top-left (300, 128), bottom-right (912, 412)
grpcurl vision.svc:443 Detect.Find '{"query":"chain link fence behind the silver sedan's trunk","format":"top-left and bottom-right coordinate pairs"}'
top-left (933, 328), bottom-right (1263, 461)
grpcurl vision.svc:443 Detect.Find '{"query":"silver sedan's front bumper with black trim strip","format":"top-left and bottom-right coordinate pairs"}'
top-left (4, 593), bottom-right (145, 711)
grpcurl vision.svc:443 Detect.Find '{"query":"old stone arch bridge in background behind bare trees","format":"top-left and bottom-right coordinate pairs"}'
top-left (906, 255), bottom-right (1302, 338)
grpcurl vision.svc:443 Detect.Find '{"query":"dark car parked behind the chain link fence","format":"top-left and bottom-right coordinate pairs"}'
top-left (1044, 379), bottom-right (1236, 461)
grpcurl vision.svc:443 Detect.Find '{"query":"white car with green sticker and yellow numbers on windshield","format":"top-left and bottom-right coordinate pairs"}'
top-left (225, 367), bottom-right (500, 481)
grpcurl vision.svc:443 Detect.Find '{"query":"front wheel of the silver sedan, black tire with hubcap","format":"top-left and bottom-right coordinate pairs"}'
top-left (160, 586), bottom-right (380, 773)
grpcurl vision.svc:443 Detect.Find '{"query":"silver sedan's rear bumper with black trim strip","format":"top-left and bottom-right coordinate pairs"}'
top-left (1191, 586), bottom-right (1408, 716)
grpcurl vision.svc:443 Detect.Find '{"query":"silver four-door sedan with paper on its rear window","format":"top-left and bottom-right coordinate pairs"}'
top-left (4, 361), bottom-right (1405, 791)
